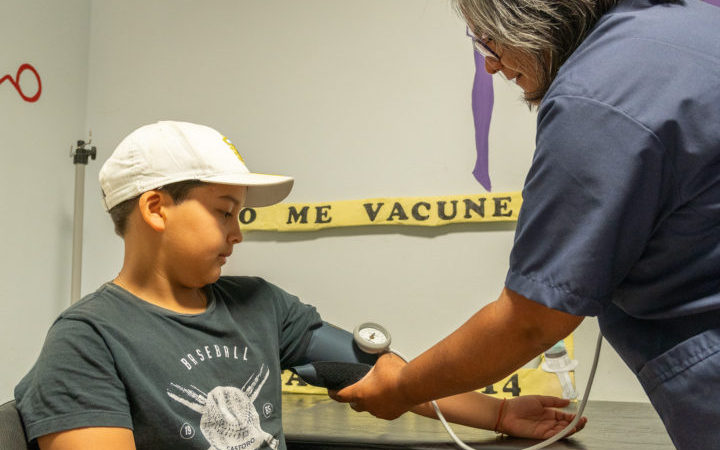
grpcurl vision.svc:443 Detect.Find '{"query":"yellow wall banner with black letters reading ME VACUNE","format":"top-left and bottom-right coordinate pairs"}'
top-left (240, 192), bottom-right (522, 231)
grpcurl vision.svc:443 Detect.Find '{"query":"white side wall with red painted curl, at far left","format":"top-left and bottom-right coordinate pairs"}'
top-left (0, 0), bottom-right (90, 402)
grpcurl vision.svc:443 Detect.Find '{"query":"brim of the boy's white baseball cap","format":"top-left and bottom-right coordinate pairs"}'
top-left (201, 173), bottom-right (295, 208)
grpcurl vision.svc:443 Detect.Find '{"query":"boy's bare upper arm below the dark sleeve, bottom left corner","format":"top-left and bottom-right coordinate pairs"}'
top-left (38, 427), bottom-right (135, 450)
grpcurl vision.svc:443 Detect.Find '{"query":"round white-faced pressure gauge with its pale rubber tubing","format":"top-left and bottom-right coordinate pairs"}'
top-left (353, 322), bottom-right (602, 450)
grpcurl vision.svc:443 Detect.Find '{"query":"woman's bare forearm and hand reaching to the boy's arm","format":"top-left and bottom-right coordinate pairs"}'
top-left (332, 288), bottom-right (583, 419)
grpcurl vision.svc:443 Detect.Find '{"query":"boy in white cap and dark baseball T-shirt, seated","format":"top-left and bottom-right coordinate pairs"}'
top-left (15, 121), bottom-right (584, 450)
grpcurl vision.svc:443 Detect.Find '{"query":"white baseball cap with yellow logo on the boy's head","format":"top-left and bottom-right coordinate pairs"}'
top-left (99, 121), bottom-right (293, 210)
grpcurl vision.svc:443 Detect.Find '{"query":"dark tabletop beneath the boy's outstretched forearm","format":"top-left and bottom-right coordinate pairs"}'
top-left (283, 394), bottom-right (675, 450)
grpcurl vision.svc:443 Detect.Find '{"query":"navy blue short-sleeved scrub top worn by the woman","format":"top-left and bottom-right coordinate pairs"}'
top-left (506, 0), bottom-right (720, 448)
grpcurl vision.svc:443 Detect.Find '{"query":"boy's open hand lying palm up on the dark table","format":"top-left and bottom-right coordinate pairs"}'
top-left (497, 395), bottom-right (587, 439)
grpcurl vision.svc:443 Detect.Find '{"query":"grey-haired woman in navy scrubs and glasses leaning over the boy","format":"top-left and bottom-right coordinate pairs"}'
top-left (336, 0), bottom-right (720, 449)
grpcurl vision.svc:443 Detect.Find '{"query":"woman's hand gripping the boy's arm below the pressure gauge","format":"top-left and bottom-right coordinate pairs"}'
top-left (328, 353), bottom-right (415, 420)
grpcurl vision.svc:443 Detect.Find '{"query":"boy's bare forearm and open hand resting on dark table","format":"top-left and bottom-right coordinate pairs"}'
top-left (411, 392), bottom-right (587, 439)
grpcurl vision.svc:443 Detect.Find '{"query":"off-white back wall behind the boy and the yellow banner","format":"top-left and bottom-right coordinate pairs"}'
top-left (0, 0), bottom-right (646, 401)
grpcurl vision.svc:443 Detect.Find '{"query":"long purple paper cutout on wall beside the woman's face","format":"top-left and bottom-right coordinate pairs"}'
top-left (472, 51), bottom-right (495, 192)
